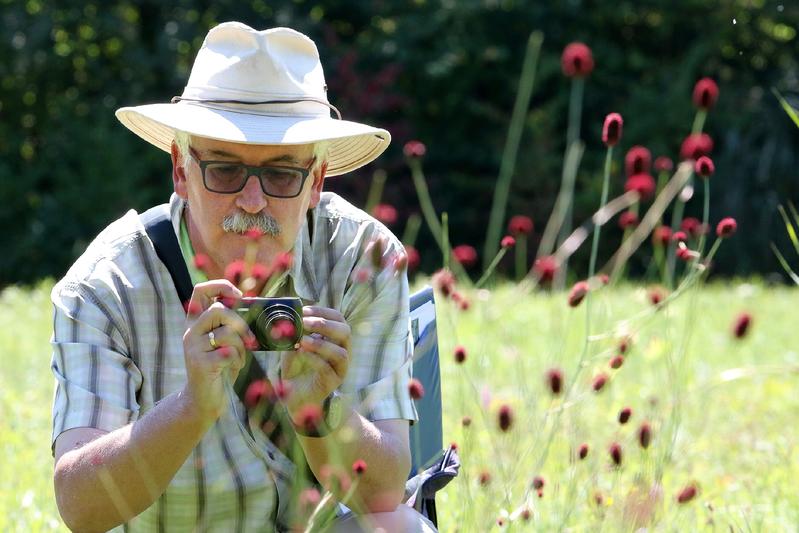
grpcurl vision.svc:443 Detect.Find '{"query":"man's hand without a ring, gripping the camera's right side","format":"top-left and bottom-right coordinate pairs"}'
top-left (281, 306), bottom-right (352, 422)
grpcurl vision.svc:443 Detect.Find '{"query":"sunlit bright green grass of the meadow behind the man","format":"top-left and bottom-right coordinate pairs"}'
top-left (0, 283), bottom-right (799, 531)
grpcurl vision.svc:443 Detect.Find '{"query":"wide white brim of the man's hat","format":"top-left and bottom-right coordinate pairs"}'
top-left (116, 104), bottom-right (391, 176)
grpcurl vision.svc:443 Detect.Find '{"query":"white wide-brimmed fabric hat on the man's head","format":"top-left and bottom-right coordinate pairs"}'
top-left (116, 22), bottom-right (391, 176)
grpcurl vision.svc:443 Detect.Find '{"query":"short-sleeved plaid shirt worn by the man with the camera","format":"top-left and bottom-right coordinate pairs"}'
top-left (51, 192), bottom-right (418, 531)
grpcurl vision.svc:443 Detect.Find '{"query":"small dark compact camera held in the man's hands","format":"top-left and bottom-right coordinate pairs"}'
top-left (236, 297), bottom-right (302, 351)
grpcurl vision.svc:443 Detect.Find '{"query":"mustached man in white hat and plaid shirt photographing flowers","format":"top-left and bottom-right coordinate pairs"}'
top-left (52, 23), bottom-right (432, 531)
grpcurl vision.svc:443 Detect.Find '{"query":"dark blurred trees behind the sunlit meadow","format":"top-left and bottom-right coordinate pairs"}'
top-left (0, 0), bottom-right (799, 289)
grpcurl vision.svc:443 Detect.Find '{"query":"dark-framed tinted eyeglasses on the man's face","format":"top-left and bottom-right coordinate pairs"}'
top-left (189, 148), bottom-right (316, 198)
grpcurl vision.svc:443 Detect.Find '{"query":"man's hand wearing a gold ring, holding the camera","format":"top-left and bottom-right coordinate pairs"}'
top-left (183, 279), bottom-right (254, 423)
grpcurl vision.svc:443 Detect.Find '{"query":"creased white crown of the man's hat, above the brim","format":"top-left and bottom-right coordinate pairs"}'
top-left (182, 22), bottom-right (328, 104)
